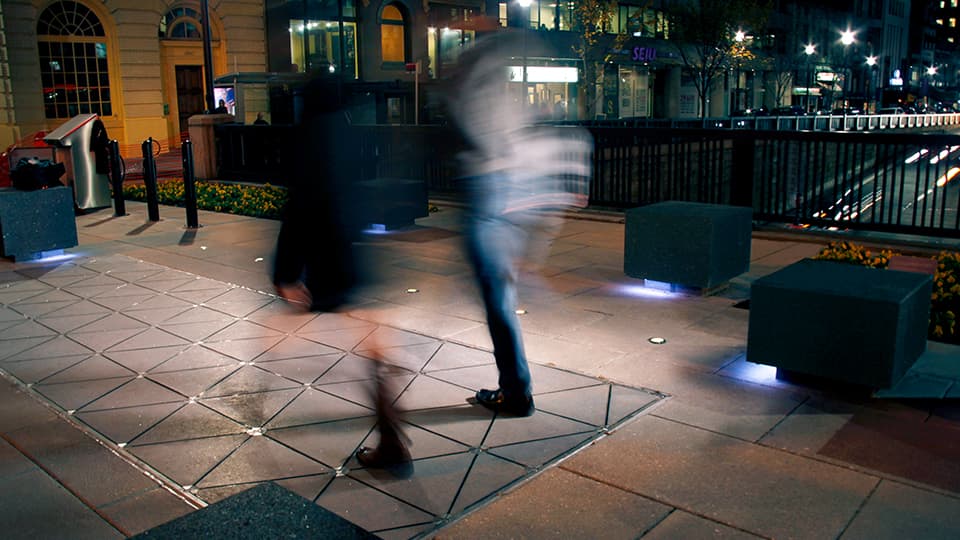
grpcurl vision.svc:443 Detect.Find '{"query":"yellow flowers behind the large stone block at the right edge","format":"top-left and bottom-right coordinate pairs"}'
top-left (814, 242), bottom-right (960, 344)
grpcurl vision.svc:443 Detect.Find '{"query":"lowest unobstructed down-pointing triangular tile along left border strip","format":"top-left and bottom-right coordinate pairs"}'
top-left (128, 434), bottom-right (250, 487)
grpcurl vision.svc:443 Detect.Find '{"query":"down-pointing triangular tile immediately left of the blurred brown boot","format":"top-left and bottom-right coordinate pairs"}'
top-left (267, 416), bottom-right (377, 468)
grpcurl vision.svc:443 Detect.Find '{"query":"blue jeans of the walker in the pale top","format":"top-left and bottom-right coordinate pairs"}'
top-left (464, 177), bottom-right (531, 396)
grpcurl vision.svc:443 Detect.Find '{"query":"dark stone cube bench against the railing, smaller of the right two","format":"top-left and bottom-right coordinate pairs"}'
top-left (623, 201), bottom-right (753, 289)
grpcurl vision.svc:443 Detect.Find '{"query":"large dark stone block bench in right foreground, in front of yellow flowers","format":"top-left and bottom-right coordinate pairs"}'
top-left (747, 259), bottom-right (933, 388)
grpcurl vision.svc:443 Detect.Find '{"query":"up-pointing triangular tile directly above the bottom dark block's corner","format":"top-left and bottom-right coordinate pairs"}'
top-left (197, 437), bottom-right (330, 488)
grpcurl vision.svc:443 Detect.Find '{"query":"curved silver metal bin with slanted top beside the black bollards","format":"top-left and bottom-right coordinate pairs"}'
top-left (43, 114), bottom-right (112, 210)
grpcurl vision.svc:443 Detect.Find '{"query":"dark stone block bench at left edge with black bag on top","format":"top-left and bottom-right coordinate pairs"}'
top-left (0, 186), bottom-right (77, 261)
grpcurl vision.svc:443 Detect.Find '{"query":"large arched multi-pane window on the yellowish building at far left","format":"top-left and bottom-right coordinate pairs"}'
top-left (37, 0), bottom-right (113, 119)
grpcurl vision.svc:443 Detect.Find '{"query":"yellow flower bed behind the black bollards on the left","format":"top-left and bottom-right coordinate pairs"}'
top-left (123, 178), bottom-right (287, 219)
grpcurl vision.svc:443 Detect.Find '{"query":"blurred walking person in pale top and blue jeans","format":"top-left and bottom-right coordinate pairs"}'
top-left (446, 21), bottom-right (592, 417)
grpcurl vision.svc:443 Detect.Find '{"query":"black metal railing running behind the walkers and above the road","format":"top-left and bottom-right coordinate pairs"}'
top-left (216, 125), bottom-right (960, 237)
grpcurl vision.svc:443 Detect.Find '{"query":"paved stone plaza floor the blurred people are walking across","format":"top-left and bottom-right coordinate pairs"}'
top-left (0, 203), bottom-right (960, 538)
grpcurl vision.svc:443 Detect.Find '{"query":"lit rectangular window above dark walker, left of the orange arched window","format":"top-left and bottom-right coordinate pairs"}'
top-left (289, 19), bottom-right (358, 79)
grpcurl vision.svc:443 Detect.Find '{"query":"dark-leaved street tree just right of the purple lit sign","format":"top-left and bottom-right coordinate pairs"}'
top-left (669, 0), bottom-right (771, 117)
